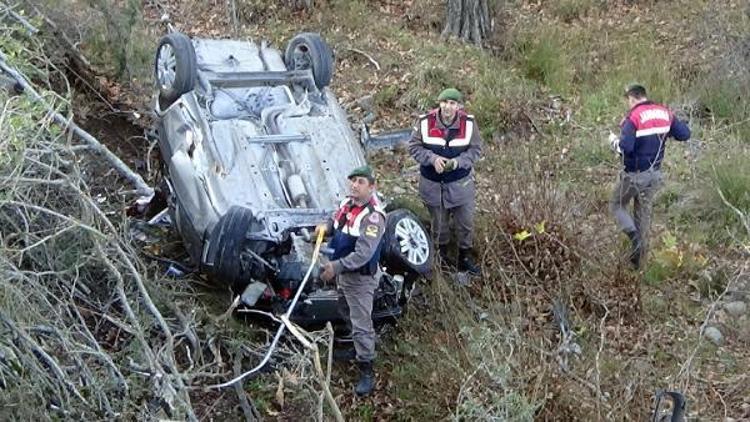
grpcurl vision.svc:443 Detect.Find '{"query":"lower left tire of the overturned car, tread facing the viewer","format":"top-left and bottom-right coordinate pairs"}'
top-left (209, 206), bottom-right (262, 289)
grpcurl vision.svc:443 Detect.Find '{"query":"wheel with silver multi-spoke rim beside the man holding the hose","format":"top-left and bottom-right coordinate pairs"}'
top-left (381, 209), bottom-right (434, 275)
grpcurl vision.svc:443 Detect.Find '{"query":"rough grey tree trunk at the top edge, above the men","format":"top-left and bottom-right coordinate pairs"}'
top-left (442, 0), bottom-right (492, 47)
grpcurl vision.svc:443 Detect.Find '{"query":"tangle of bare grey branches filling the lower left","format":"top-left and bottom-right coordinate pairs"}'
top-left (0, 23), bottom-right (340, 420)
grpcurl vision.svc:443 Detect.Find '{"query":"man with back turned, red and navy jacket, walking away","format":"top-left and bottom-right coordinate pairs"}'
top-left (609, 84), bottom-right (690, 269)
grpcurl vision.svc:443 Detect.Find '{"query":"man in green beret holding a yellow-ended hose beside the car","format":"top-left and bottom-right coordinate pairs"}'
top-left (320, 166), bottom-right (385, 396)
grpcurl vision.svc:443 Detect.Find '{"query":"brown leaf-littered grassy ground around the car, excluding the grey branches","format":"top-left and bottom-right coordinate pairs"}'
top-left (0, 0), bottom-right (750, 420)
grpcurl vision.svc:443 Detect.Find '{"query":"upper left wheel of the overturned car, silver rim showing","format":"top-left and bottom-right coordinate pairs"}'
top-left (154, 32), bottom-right (198, 108)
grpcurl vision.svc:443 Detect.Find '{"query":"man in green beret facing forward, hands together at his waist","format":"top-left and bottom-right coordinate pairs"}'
top-left (409, 88), bottom-right (482, 274)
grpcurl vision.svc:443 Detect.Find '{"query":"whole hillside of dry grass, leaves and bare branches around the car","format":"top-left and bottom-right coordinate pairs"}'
top-left (0, 0), bottom-right (750, 421)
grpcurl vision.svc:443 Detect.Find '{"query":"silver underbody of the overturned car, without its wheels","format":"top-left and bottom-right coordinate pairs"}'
top-left (154, 38), bottom-right (365, 264)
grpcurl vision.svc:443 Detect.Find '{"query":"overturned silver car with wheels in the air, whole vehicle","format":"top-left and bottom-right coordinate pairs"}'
top-left (153, 32), bottom-right (433, 323)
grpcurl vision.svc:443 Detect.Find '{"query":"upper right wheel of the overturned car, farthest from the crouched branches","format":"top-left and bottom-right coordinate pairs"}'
top-left (284, 32), bottom-right (333, 89)
